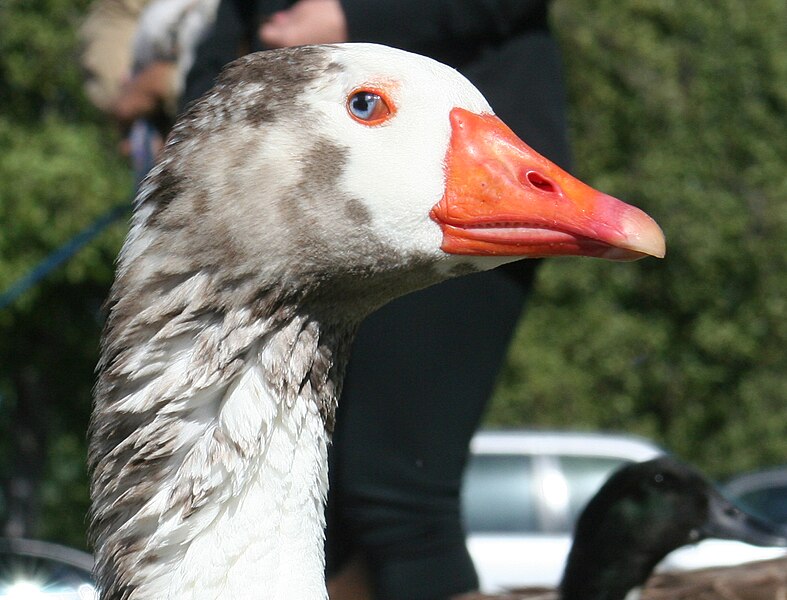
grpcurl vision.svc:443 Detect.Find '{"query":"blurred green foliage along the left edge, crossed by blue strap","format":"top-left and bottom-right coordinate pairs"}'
top-left (0, 0), bottom-right (131, 546)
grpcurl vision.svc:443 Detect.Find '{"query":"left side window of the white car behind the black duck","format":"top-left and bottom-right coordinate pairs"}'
top-left (462, 454), bottom-right (538, 533)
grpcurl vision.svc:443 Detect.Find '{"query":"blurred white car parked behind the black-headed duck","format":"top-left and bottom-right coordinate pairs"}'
top-left (462, 430), bottom-right (785, 593)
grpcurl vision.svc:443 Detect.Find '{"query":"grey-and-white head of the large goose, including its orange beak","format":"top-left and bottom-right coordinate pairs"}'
top-left (123, 44), bottom-right (664, 322)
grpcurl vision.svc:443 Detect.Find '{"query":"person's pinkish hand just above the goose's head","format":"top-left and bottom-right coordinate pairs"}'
top-left (259, 0), bottom-right (347, 48)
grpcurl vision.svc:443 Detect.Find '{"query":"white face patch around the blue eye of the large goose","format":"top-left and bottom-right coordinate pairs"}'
top-left (320, 44), bottom-right (492, 261)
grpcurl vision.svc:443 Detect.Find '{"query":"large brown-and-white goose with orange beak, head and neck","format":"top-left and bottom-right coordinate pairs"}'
top-left (88, 44), bottom-right (665, 600)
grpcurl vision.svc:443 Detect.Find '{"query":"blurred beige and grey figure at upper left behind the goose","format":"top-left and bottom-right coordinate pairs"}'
top-left (80, 0), bottom-right (218, 183)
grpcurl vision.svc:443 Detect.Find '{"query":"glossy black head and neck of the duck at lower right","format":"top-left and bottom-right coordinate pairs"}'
top-left (462, 456), bottom-right (787, 600)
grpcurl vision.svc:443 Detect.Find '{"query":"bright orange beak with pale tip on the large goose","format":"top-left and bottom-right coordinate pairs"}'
top-left (431, 108), bottom-right (665, 260)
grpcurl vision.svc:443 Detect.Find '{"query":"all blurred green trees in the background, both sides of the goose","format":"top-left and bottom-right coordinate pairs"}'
top-left (0, 0), bottom-right (787, 547)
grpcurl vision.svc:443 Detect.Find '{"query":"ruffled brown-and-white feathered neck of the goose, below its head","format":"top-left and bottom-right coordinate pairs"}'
top-left (90, 274), bottom-right (352, 600)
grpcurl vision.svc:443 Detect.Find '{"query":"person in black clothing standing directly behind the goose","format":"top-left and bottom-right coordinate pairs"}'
top-left (183, 0), bottom-right (569, 600)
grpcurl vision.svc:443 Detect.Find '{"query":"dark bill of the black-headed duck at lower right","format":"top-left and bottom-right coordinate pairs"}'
top-left (700, 494), bottom-right (787, 547)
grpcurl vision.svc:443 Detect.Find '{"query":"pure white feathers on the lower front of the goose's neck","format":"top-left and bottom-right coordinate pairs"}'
top-left (129, 344), bottom-right (328, 600)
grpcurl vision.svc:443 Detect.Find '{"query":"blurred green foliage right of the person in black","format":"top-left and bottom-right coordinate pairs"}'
top-left (489, 0), bottom-right (787, 476)
